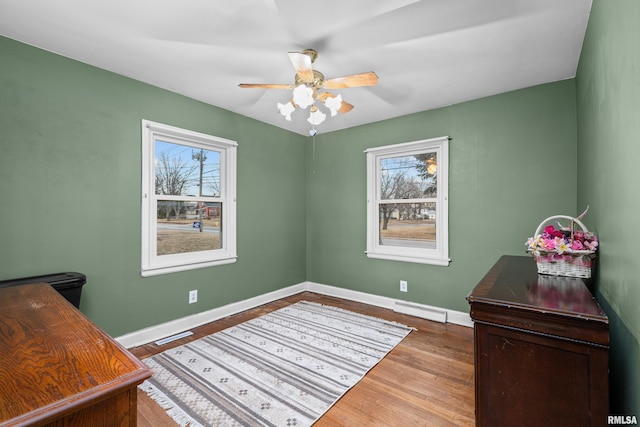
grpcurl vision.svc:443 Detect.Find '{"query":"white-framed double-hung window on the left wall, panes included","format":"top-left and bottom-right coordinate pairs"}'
top-left (142, 120), bottom-right (237, 276)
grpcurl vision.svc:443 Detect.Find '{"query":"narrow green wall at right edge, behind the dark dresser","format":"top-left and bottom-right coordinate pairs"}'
top-left (576, 0), bottom-right (640, 416)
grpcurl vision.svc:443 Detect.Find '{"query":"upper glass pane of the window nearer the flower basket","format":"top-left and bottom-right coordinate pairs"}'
top-left (380, 152), bottom-right (437, 200)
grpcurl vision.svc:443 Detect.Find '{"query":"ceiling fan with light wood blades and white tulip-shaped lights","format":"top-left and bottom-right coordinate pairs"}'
top-left (239, 49), bottom-right (378, 125)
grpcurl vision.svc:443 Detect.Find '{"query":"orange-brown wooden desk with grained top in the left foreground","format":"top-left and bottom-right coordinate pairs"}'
top-left (0, 283), bottom-right (152, 427)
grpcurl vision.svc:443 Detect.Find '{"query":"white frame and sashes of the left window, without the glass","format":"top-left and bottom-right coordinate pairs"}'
top-left (141, 120), bottom-right (238, 277)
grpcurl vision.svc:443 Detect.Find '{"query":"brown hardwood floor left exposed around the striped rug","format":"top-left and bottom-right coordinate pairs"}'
top-left (130, 292), bottom-right (475, 427)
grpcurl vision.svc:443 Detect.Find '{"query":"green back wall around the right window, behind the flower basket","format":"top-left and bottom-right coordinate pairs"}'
top-left (307, 80), bottom-right (577, 312)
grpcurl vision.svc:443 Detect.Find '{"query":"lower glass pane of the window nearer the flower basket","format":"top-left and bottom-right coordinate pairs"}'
top-left (379, 202), bottom-right (436, 249)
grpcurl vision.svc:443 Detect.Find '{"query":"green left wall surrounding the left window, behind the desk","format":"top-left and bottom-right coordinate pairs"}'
top-left (0, 38), bottom-right (306, 336)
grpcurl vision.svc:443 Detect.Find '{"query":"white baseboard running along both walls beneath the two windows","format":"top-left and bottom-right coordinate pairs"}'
top-left (116, 282), bottom-right (473, 348)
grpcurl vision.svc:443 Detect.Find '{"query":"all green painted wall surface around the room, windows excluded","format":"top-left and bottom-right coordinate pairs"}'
top-left (0, 5), bottom-right (640, 415)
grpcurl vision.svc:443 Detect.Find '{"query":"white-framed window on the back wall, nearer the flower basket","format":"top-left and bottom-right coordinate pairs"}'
top-left (365, 136), bottom-right (450, 265)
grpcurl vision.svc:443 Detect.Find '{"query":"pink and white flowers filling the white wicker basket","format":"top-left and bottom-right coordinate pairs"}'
top-left (526, 225), bottom-right (598, 256)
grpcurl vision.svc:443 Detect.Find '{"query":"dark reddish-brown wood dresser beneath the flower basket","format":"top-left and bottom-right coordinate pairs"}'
top-left (467, 256), bottom-right (609, 427)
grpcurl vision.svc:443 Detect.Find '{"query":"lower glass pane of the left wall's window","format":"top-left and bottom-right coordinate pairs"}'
top-left (157, 200), bottom-right (222, 255)
